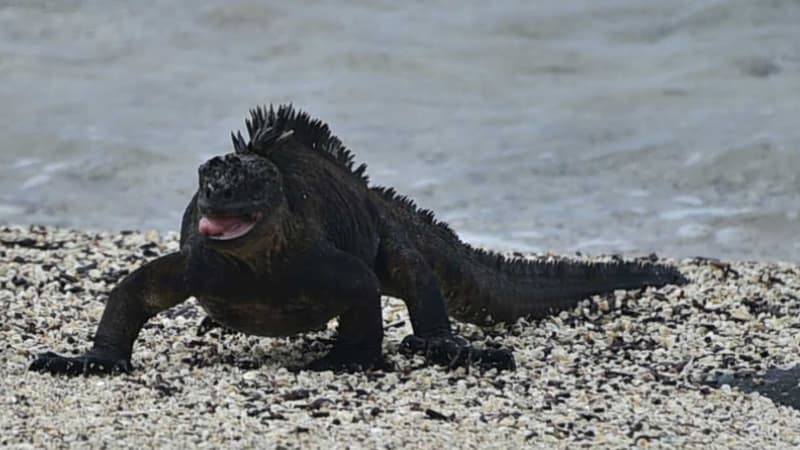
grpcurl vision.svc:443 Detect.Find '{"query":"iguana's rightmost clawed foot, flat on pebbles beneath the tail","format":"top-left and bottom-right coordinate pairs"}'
top-left (400, 335), bottom-right (516, 370)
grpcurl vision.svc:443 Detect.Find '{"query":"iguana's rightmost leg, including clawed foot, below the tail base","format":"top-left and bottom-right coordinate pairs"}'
top-left (379, 241), bottom-right (515, 370)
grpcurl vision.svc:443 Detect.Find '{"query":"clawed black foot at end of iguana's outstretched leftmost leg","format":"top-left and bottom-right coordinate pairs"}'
top-left (28, 351), bottom-right (133, 376)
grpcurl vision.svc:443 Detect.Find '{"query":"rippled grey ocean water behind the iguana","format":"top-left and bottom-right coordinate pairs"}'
top-left (0, 0), bottom-right (800, 261)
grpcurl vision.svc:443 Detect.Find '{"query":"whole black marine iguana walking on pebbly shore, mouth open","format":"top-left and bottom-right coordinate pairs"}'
top-left (30, 105), bottom-right (682, 375)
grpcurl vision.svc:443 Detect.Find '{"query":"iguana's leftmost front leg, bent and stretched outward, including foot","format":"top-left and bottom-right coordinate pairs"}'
top-left (30, 253), bottom-right (188, 375)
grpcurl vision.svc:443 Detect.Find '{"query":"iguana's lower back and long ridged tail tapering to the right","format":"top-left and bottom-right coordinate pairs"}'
top-left (373, 187), bottom-right (685, 325)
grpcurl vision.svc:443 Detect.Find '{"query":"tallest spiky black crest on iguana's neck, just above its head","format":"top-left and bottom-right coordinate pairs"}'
top-left (231, 104), bottom-right (368, 182)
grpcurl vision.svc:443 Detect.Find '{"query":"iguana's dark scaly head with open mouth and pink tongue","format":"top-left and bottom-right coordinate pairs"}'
top-left (197, 153), bottom-right (284, 241)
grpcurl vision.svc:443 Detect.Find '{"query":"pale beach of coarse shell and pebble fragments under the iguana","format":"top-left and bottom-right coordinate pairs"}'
top-left (0, 226), bottom-right (800, 448)
